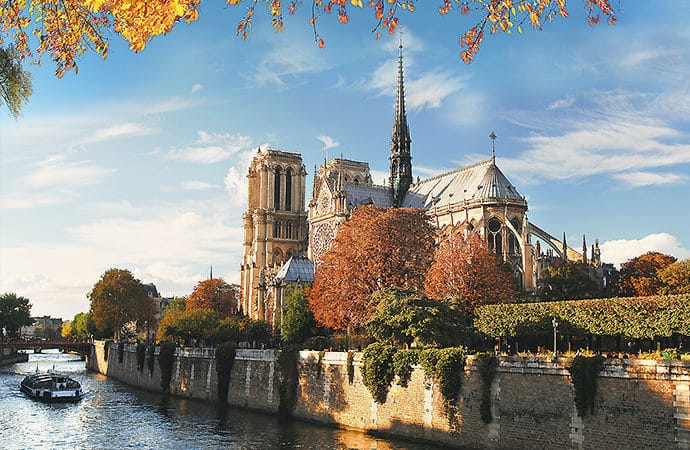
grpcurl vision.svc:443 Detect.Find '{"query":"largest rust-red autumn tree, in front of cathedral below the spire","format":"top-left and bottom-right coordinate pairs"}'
top-left (309, 205), bottom-right (436, 333)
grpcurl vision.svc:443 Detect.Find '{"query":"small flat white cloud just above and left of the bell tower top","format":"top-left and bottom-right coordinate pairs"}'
top-left (164, 131), bottom-right (252, 164)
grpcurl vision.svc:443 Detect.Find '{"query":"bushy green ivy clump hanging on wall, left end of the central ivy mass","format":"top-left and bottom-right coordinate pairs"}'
top-left (361, 342), bottom-right (396, 405)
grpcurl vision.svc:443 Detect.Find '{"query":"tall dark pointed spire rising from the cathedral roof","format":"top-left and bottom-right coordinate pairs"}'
top-left (389, 40), bottom-right (412, 206)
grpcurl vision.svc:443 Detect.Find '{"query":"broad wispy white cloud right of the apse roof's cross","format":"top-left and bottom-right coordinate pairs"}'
top-left (500, 92), bottom-right (690, 186)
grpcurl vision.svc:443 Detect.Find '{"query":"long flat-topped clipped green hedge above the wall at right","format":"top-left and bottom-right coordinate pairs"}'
top-left (474, 294), bottom-right (690, 339)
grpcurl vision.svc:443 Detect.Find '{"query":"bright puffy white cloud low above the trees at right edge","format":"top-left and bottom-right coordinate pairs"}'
top-left (601, 233), bottom-right (690, 266)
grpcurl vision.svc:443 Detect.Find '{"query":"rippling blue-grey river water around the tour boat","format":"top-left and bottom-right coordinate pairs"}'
top-left (0, 351), bottom-right (440, 450)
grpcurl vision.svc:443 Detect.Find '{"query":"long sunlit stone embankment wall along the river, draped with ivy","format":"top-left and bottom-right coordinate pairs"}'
top-left (88, 345), bottom-right (690, 449)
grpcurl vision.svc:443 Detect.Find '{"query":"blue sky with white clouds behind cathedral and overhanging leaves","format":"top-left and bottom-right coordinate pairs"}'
top-left (0, 1), bottom-right (690, 319)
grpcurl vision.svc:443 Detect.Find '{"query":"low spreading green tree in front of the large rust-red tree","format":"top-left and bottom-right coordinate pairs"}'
top-left (367, 289), bottom-right (467, 347)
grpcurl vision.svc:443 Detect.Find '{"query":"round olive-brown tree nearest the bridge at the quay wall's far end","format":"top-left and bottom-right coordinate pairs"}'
top-left (88, 269), bottom-right (156, 338)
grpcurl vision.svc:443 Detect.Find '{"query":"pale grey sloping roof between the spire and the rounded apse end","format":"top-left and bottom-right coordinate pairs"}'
top-left (402, 158), bottom-right (525, 210)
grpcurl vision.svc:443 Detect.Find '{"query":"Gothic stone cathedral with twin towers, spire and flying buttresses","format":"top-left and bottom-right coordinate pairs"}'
top-left (240, 46), bottom-right (601, 323)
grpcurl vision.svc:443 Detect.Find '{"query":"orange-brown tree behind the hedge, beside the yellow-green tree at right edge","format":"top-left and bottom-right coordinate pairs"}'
top-left (618, 252), bottom-right (676, 297)
